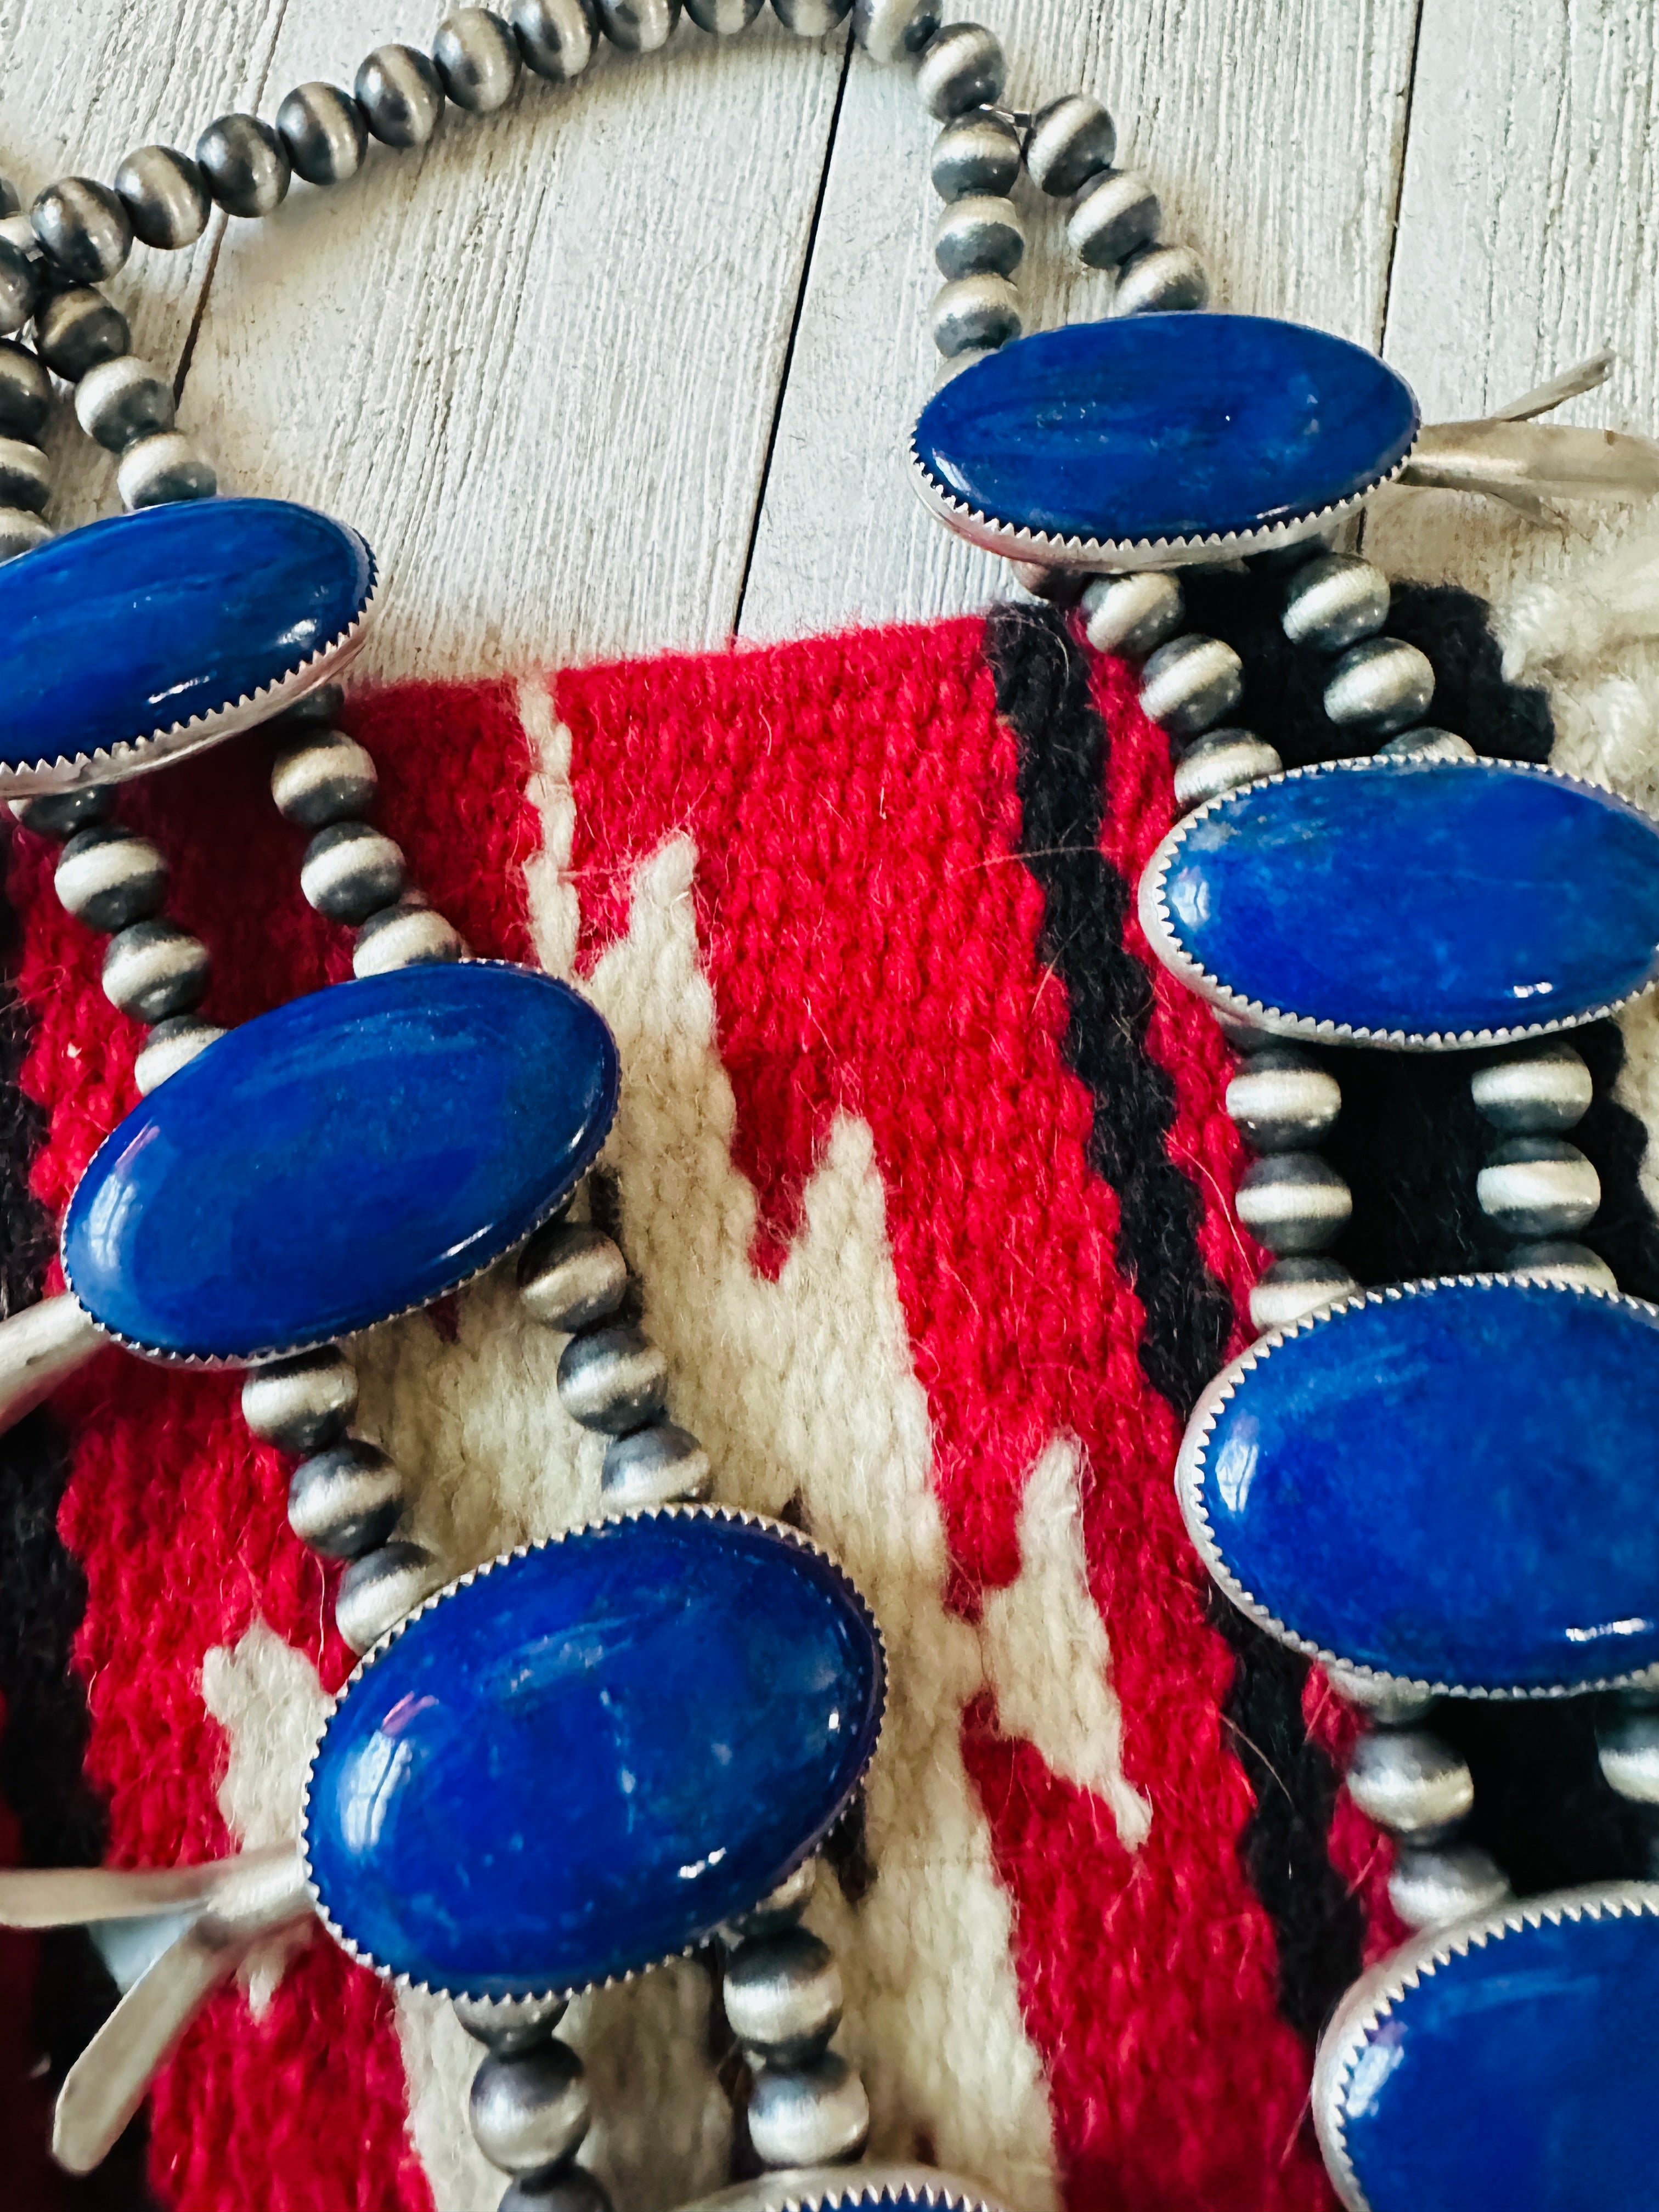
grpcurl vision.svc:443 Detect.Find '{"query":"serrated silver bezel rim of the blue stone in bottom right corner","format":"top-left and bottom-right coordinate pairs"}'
top-left (1314, 1882), bottom-right (1659, 2212)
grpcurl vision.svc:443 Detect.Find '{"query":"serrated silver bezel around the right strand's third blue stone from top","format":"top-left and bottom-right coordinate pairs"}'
top-left (1175, 1272), bottom-right (1659, 1703)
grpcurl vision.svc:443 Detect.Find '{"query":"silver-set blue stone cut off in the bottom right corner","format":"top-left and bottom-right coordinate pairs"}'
top-left (1314, 1882), bottom-right (1659, 2212)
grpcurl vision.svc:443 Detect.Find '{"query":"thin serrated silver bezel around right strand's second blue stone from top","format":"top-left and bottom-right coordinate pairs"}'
top-left (1137, 754), bottom-right (1652, 1053)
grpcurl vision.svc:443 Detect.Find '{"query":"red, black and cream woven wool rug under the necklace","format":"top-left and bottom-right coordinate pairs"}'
top-left (0, 546), bottom-right (1659, 2212)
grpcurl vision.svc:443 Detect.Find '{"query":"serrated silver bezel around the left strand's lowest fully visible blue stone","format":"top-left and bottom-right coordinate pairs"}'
top-left (296, 1504), bottom-right (898, 2008)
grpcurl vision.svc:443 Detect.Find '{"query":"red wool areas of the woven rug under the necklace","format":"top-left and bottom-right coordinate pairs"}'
top-left (11, 622), bottom-right (1378, 2212)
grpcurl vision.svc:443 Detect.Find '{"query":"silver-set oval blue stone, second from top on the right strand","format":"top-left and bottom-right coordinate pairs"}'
top-left (1142, 759), bottom-right (1659, 1046)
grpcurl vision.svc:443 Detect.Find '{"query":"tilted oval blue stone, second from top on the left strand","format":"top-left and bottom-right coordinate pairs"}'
top-left (62, 960), bottom-right (617, 1361)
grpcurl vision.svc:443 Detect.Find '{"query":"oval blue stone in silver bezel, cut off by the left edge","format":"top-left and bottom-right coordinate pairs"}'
top-left (0, 500), bottom-right (374, 794)
